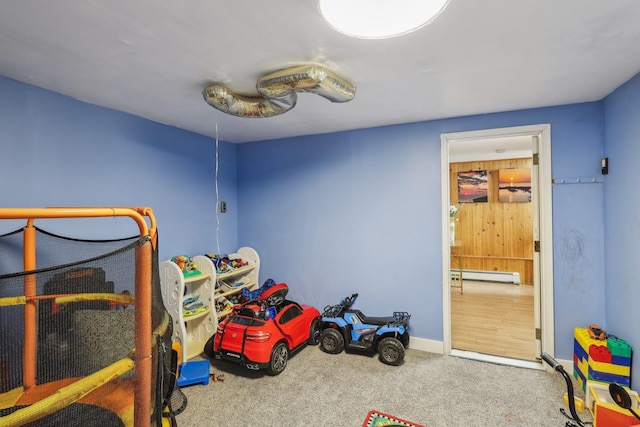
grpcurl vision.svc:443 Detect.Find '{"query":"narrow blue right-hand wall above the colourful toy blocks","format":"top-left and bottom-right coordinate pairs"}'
top-left (604, 74), bottom-right (640, 387)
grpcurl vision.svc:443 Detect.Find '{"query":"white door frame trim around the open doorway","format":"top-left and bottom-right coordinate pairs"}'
top-left (440, 124), bottom-right (555, 364)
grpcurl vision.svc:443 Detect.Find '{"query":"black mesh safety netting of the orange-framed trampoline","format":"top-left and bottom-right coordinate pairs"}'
top-left (0, 229), bottom-right (175, 426)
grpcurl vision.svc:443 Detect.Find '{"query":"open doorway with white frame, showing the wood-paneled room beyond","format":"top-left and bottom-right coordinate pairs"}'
top-left (442, 125), bottom-right (553, 366)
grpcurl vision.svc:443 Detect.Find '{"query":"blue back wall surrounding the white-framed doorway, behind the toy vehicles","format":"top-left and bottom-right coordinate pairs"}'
top-left (238, 102), bottom-right (604, 359)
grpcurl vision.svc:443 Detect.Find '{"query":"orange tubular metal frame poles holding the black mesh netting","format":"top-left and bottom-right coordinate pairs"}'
top-left (0, 207), bottom-right (158, 426)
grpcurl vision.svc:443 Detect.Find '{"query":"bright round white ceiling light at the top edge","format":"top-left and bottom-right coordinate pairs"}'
top-left (320, 0), bottom-right (449, 39)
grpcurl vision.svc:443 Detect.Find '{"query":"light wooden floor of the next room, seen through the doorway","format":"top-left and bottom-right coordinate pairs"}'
top-left (451, 280), bottom-right (537, 360)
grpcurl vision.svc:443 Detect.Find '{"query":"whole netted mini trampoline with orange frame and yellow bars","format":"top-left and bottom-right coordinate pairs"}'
top-left (0, 207), bottom-right (186, 427)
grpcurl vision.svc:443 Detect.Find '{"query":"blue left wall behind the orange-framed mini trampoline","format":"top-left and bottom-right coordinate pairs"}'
top-left (0, 78), bottom-right (237, 262)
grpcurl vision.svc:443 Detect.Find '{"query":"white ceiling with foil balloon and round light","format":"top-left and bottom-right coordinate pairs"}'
top-left (0, 0), bottom-right (640, 143)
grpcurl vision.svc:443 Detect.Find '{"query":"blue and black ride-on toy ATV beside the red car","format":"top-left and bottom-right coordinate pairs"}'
top-left (320, 294), bottom-right (411, 366)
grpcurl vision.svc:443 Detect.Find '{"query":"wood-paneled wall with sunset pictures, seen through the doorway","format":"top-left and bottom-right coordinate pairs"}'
top-left (449, 158), bottom-right (533, 285)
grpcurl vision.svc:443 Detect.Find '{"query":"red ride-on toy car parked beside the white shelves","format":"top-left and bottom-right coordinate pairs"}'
top-left (205, 283), bottom-right (320, 375)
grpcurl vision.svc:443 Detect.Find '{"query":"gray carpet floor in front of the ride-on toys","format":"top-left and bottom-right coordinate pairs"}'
top-left (172, 346), bottom-right (591, 427)
